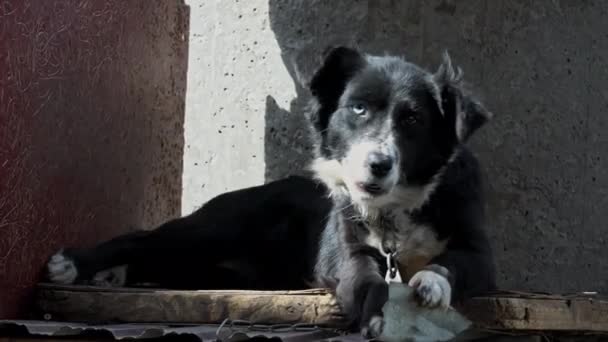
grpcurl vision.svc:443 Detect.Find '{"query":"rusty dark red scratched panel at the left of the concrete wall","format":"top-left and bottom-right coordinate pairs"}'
top-left (0, 0), bottom-right (189, 318)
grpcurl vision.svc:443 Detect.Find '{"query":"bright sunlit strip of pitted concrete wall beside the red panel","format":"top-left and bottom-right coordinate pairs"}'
top-left (182, 0), bottom-right (299, 213)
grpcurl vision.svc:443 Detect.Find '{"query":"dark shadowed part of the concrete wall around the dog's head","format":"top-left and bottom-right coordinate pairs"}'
top-left (265, 0), bottom-right (608, 292)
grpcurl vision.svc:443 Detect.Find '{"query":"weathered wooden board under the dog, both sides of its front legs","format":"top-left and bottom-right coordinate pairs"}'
top-left (38, 284), bottom-right (608, 332)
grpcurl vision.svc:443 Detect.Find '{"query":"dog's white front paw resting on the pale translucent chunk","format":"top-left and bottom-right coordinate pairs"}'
top-left (409, 270), bottom-right (452, 309)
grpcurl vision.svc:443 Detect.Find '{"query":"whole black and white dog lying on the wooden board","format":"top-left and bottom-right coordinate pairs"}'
top-left (48, 47), bottom-right (494, 337)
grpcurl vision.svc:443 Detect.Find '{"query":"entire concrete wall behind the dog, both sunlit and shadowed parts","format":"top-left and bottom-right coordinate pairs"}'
top-left (183, 0), bottom-right (608, 292)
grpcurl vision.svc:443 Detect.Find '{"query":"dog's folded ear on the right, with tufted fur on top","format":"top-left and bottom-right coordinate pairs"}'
top-left (433, 52), bottom-right (492, 142)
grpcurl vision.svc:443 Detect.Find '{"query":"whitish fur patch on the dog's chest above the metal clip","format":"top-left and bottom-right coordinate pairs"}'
top-left (363, 210), bottom-right (447, 279)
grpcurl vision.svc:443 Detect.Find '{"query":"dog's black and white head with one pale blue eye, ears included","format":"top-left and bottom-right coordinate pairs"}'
top-left (309, 47), bottom-right (491, 211)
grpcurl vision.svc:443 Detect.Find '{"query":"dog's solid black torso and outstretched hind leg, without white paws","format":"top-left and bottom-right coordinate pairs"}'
top-left (55, 176), bottom-right (331, 290)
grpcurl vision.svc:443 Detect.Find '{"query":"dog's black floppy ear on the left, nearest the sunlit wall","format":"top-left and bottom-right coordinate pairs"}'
top-left (309, 46), bottom-right (365, 132)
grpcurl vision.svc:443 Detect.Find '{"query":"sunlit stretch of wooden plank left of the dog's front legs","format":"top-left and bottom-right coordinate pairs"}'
top-left (38, 285), bottom-right (340, 326)
